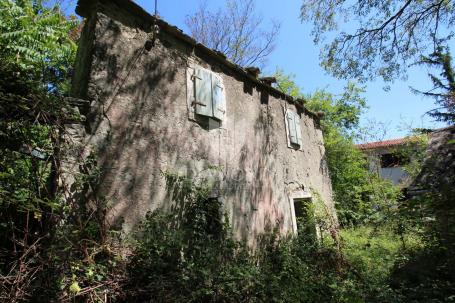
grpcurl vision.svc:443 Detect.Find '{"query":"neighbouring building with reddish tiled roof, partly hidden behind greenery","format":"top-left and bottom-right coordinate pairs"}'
top-left (356, 138), bottom-right (410, 186)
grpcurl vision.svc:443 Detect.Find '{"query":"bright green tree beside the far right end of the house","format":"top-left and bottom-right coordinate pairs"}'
top-left (275, 70), bottom-right (398, 226)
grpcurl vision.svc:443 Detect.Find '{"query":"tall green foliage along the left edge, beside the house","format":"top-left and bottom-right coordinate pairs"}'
top-left (0, 0), bottom-right (79, 247)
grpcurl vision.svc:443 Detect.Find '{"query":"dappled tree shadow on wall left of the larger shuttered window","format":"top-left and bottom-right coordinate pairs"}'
top-left (75, 15), bottom-right (194, 230)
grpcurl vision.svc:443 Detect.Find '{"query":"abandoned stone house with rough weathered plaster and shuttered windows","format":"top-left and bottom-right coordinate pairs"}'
top-left (64, 0), bottom-right (336, 245)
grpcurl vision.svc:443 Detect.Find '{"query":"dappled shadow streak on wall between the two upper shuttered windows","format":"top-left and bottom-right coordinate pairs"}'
top-left (225, 104), bottom-right (284, 245)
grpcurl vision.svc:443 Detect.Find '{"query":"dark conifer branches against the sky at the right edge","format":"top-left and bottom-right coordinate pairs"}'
top-left (411, 45), bottom-right (455, 123)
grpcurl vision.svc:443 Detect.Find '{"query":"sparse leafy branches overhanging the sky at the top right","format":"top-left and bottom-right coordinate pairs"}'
top-left (301, 0), bottom-right (455, 81)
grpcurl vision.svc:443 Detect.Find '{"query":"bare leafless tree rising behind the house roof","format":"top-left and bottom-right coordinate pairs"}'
top-left (185, 0), bottom-right (280, 67)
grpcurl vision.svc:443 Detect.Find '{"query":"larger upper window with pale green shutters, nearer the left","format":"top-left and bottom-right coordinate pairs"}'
top-left (191, 68), bottom-right (226, 121)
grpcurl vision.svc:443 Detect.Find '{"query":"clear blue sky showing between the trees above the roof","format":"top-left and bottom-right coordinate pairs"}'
top-left (65, 0), bottom-right (450, 139)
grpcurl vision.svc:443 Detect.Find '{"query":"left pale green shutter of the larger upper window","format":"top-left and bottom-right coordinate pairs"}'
top-left (193, 68), bottom-right (213, 117)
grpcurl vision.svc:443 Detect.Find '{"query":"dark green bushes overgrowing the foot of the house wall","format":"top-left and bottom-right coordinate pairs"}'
top-left (126, 173), bottom-right (374, 302)
